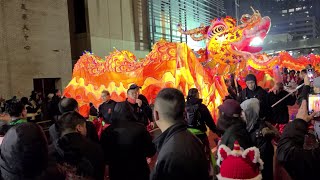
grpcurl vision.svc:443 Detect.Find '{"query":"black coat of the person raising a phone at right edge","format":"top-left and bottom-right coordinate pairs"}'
top-left (277, 119), bottom-right (320, 180)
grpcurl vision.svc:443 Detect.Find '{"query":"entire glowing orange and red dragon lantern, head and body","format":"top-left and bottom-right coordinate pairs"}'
top-left (64, 7), bottom-right (320, 117)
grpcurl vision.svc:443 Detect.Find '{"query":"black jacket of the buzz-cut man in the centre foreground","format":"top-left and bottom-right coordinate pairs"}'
top-left (150, 123), bottom-right (209, 180)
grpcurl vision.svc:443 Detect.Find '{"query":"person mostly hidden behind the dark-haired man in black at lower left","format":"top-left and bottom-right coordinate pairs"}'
top-left (49, 98), bottom-right (99, 143)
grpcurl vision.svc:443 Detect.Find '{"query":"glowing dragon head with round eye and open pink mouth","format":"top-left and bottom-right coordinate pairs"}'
top-left (178, 8), bottom-right (271, 67)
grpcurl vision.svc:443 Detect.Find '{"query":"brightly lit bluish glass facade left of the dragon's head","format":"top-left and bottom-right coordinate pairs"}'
top-left (148, 0), bottom-right (224, 50)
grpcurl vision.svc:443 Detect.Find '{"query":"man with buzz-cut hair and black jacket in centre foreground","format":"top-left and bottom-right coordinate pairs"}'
top-left (150, 88), bottom-right (209, 180)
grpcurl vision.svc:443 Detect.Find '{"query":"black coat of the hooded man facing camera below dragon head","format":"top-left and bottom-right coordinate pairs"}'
top-left (238, 86), bottom-right (270, 118)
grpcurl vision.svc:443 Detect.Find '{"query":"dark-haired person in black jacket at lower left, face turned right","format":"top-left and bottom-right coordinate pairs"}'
top-left (49, 111), bottom-right (105, 180)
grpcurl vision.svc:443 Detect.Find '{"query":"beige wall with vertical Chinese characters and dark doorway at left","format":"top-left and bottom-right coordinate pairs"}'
top-left (0, 0), bottom-right (72, 99)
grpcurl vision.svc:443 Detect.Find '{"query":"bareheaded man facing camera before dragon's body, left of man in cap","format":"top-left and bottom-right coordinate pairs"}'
top-left (98, 91), bottom-right (116, 124)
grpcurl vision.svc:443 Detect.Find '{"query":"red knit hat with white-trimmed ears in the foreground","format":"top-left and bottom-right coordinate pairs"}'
top-left (217, 141), bottom-right (263, 180)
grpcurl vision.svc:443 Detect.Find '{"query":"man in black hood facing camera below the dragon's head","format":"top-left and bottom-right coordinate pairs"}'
top-left (238, 74), bottom-right (270, 119)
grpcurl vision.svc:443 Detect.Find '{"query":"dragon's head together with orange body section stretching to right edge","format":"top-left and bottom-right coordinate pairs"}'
top-left (178, 8), bottom-right (320, 83)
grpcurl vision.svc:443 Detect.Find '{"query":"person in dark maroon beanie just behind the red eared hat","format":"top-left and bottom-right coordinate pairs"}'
top-left (217, 99), bottom-right (253, 148)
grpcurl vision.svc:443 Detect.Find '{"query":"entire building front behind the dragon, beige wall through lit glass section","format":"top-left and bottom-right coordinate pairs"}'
top-left (0, 0), bottom-right (224, 99)
